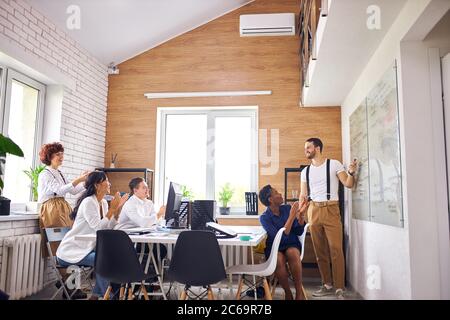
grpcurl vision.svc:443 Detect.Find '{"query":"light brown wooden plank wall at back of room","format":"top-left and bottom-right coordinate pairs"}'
top-left (105, 0), bottom-right (342, 208)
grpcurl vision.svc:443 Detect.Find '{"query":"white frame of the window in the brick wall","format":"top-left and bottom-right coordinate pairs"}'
top-left (0, 65), bottom-right (46, 201)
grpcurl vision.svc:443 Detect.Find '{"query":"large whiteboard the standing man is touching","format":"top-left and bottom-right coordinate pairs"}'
top-left (350, 62), bottom-right (403, 227)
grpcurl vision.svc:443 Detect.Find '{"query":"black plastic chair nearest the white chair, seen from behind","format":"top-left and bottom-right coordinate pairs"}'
top-left (169, 230), bottom-right (227, 300)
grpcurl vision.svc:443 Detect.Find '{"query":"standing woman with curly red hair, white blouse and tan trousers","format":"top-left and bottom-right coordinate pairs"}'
top-left (38, 142), bottom-right (89, 228)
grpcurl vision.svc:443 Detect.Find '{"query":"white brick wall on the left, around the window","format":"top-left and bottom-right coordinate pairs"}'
top-left (0, 0), bottom-right (108, 205)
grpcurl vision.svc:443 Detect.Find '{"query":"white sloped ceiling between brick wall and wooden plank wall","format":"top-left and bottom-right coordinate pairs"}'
top-left (27, 0), bottom-right (253, 65)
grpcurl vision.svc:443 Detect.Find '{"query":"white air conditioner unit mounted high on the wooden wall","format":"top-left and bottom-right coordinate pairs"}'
top-left (239, 13), bottom-right (295, 37)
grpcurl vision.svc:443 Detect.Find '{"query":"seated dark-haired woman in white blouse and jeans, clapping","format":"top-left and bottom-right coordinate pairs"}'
top-left (56, 171), bottom-right (128, 297)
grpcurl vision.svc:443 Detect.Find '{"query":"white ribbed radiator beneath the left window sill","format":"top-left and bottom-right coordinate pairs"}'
top-left (0, 234), bottom-right (44, 300)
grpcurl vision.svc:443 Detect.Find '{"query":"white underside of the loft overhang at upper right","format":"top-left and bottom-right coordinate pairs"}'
top-left (303, 0), bottom-right (406, 106)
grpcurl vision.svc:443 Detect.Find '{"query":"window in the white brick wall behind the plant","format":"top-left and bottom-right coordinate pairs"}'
top-left (0, 69), bottom-right (45, 203)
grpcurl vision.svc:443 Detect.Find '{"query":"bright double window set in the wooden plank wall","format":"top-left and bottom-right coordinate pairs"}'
top-left (156, 107), bottom-right (258, 212)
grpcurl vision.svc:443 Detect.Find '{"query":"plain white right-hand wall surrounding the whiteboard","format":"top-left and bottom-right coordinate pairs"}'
top-left (342, 0), bottom-right (448, 299)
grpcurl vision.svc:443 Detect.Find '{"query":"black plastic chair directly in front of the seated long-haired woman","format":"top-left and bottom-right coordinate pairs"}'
top-left (95, 230), bottom-right (157, 300)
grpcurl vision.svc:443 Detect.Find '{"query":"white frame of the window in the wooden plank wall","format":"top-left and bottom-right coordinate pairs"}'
top-left (155, 106), bottom-right (258, 213)
